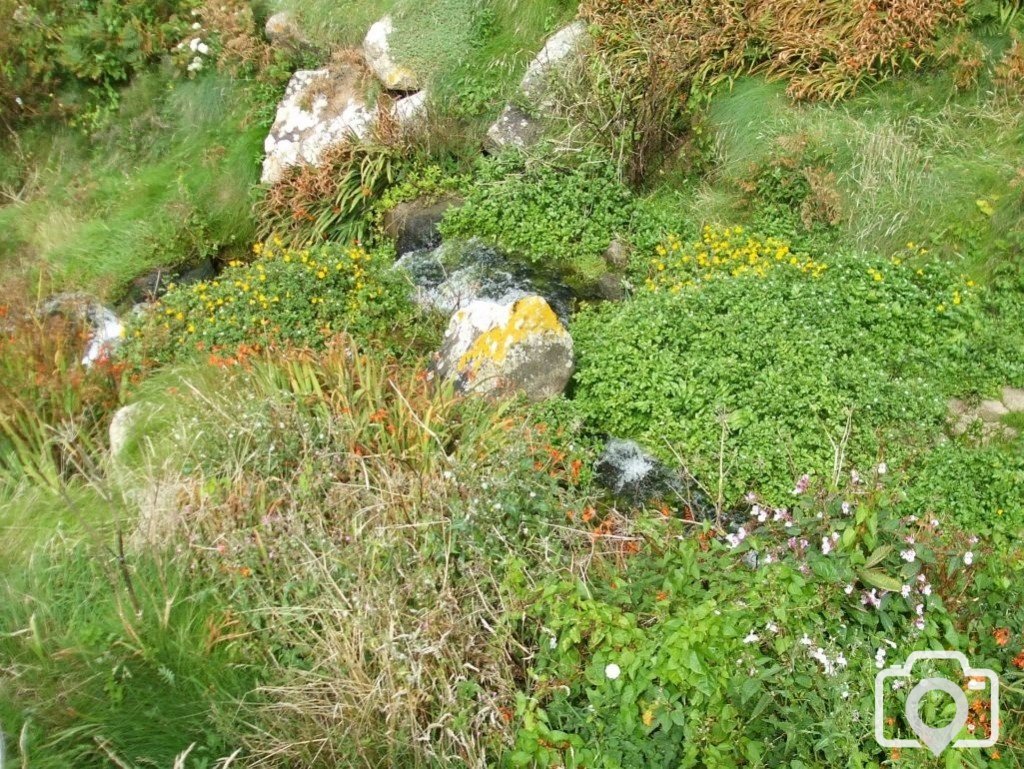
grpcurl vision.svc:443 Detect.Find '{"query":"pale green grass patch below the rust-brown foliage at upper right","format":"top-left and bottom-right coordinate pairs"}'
top-left (647, 73), bottom-right (1024, 266)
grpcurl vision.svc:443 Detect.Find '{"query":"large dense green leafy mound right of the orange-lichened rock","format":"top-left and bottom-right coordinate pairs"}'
top-left (573, 237), bottom-right (1024, 498)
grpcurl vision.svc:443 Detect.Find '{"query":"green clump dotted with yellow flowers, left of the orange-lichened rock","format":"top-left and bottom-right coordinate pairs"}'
top-left (126, 239), bottom-right (416, 360)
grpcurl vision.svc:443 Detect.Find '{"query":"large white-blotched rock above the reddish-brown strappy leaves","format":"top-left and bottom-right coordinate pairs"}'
top-left (261, 67), bottom-right (376, 184)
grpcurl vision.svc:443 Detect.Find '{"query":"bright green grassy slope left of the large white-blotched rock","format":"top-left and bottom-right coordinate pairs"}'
top-left (0, 74), bottom-right (266, 299)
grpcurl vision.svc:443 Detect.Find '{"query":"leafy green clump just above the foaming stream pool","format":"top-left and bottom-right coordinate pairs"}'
top-left (440, 153), bottom-right (633, 275)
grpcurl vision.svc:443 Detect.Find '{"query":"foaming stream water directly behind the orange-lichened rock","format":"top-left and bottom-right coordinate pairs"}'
top-left (395, 240), bottom-right (572, 324)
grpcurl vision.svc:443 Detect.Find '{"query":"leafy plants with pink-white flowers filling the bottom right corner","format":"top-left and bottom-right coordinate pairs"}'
top-left (509, 476), bottom-right (1024, 767)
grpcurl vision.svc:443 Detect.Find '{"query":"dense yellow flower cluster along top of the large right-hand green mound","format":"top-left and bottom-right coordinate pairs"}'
top-left (647, 225), bottom-right (827, 292)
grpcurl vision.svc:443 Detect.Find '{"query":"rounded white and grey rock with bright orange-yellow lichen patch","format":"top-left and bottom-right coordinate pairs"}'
top-left (436, 296), bottom-right (573, 400)
